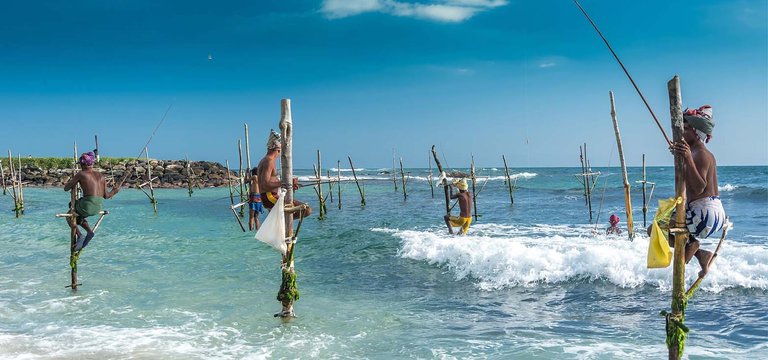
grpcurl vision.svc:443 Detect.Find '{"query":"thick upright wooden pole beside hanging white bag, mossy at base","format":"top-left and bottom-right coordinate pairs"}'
top-left (277, 99), bottom-right (298, 317)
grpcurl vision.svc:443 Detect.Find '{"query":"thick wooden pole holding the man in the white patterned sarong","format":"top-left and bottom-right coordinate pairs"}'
top-left (667, 75), bottom-right (688, 360)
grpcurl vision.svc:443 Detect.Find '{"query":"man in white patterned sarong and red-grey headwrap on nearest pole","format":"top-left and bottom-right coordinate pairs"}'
top-left (670, 105), bottom-right (726, 276)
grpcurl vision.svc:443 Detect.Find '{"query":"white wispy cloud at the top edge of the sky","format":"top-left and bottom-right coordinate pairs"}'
top-left (321, 0), bottom-right (507, 22)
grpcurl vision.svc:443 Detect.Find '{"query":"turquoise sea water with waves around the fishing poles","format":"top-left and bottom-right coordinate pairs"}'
top-left (0, 167), bottom-right (768, 359)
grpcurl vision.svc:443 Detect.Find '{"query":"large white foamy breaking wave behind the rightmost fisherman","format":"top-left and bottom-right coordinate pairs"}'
top-left (372, 224), bottom-right (768, 292)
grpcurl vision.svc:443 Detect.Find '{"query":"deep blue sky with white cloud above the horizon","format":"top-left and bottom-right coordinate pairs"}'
top-left (0, 0), bottom-right (768, 168)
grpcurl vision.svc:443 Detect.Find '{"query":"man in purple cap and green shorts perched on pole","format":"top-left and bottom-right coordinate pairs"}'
top-left (64, 152), bottom-right (120, 251)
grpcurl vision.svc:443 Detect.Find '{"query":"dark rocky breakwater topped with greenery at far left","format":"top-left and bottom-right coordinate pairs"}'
top-left (12, 160), bottom-right (237, 188)
